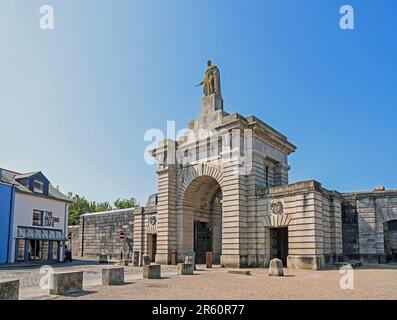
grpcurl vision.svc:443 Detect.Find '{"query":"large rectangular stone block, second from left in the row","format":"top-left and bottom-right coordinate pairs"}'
top-left (50, 271), bottom-right (83, 295)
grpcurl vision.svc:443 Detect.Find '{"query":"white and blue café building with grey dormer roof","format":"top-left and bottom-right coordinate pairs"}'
top-left (0, 168), bottom-right (70, 264)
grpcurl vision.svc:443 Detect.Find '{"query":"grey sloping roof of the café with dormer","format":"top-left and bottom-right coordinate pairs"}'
top-left (0, 168), bottom-right (70, 202)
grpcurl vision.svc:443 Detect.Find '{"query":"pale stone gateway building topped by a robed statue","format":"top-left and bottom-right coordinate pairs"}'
top-left (133, 62), bottom-right (397, 270)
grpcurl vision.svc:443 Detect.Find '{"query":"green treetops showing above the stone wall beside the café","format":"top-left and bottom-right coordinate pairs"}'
top-left (68, 192), bottom-right (138, 226)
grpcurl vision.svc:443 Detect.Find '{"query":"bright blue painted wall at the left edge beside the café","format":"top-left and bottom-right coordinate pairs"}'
top-left (0, 176), bottom-right (15, 264)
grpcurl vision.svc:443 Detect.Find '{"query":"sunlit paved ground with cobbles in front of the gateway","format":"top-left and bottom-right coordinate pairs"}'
top-left (0, 261), bottom-right (397, 300)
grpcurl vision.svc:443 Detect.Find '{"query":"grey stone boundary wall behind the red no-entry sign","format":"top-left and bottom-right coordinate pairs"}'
top-left (79, 208), bottom-right (135, 259)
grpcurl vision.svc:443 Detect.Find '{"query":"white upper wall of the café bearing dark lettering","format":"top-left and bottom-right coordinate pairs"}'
top-left (11, 192), bottom-right (68, 261)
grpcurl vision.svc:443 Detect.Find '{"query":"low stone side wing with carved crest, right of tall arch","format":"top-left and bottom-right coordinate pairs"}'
top-left (257, 180), bottom-right (342, 269)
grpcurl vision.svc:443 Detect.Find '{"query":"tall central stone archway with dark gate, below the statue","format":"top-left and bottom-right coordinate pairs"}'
top-left (177, 166), bottom-right (222, 264)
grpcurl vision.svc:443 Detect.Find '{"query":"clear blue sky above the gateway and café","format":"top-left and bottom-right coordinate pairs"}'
top-left (0, 0), bottom-right (397, 203)
